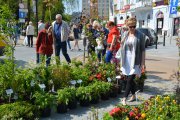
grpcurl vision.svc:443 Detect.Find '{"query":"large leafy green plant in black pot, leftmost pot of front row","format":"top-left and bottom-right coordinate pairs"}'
top-left (33, 92), bottom-right (54, 117)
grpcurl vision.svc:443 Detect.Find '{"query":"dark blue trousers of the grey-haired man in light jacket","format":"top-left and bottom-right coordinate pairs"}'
top-left (55, 41), bottom-right (71, 64)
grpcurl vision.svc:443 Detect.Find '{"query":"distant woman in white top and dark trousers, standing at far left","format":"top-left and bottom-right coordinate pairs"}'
top-left (26, 21), bottom-right (34, 47)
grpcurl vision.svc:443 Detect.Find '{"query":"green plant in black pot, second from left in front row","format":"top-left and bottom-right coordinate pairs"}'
top-left (57, 88), bottom-right (71, 113)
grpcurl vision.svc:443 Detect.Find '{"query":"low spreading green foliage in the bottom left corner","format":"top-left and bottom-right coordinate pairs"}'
top-left (0, 101), bottom-right (35, 120)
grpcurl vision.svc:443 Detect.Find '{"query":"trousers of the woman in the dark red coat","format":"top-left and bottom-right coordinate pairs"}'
top-left (37, 53), bottom-right (51, 67)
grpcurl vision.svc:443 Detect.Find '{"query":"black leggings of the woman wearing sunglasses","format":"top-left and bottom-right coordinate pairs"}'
top-left (124, 75), bottom-right (136, 98)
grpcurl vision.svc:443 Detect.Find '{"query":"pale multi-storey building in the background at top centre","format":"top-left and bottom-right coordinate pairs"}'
top-left (82, 0), bottom-right (109, 20)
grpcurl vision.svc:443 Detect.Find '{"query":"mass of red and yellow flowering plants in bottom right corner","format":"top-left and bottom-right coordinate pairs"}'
top-left (103, 95), bottom-right (180, 120)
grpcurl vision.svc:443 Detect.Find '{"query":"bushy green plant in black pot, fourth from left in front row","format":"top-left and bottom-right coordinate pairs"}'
top-left (76, 86), bottom-right (91, 106)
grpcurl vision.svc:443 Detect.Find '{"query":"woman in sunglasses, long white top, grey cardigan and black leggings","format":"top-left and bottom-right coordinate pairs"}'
top-left (120, 18), bottom-right (145, 105)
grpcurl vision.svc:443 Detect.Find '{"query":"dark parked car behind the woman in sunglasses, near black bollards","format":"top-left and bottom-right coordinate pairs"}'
top-left (137, 28), bottom-right (158, 47)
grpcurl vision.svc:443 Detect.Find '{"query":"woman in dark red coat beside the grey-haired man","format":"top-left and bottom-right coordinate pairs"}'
top-left (36, 23), bottom-right (53, 66)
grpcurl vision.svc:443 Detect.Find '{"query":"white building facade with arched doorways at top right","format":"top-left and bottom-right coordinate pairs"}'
top-left (110, 0), bottom-right (180, 35)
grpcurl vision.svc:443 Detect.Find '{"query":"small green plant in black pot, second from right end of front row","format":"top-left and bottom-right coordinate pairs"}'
top-left (100, 82), bottom-right (112, 100)
